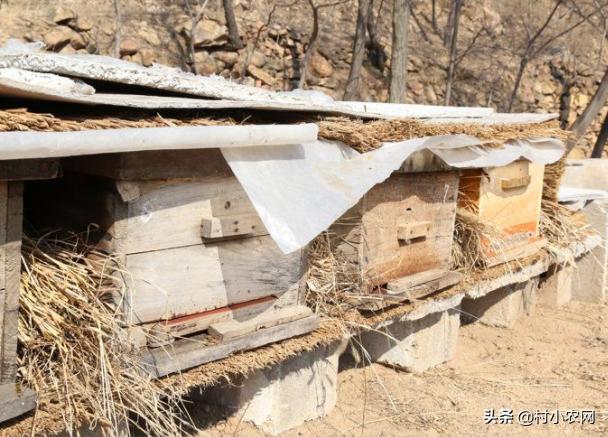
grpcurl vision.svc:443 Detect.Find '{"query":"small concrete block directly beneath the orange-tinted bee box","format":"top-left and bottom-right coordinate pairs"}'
top-left (462, 277), bottom-right (538, 328)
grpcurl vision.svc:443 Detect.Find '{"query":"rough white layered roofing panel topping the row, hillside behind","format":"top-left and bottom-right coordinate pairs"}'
top-left (0, 41), bottom-right (493, 119)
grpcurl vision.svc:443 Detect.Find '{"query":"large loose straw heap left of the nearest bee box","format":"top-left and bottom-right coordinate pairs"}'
top-left (18, 235), bottom-right (183, 436)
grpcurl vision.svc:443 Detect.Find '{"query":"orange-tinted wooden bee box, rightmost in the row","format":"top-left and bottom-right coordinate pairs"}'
top-left (458, 160), bottom-right (545, 266)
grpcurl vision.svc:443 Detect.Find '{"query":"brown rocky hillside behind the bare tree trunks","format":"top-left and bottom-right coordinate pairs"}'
top-left (0, 0), bottom-right (607, 156)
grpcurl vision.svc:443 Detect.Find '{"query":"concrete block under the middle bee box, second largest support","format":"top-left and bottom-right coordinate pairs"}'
top-left (360, 308), bottom-right (460, 372)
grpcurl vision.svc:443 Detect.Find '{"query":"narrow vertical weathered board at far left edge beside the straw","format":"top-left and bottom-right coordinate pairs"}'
top-left (0, 182), bottom-right (23, 383)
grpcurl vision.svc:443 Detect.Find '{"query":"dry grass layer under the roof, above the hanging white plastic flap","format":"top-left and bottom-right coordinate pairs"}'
top-left (317, 117), bottom-right (569, 153)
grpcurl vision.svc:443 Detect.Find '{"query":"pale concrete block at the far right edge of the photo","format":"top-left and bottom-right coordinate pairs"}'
top-left (572, 200), bottom-right (608, 302)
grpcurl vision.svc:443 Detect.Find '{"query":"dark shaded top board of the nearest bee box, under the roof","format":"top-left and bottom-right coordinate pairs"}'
top-left (63, 149), bottom-right (232, 180)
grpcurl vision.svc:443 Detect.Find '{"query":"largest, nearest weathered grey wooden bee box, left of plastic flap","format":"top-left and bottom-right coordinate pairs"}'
top-left (29, 150), bottom-right (317, 375)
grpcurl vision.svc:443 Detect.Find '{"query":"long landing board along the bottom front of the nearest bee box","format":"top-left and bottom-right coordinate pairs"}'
top-left (142, 315), bottom-right (319, 378)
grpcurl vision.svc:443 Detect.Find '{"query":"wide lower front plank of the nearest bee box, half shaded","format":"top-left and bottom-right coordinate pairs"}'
top-left (126, 236), bottom-right (303, 323)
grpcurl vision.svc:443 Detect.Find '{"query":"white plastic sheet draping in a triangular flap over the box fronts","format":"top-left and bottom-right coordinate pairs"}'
top-left (222, 135), bottom-right (564, 253)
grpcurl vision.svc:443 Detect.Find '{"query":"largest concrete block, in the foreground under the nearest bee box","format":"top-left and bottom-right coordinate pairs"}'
top-left (202, 342), bottom-right (346, 435)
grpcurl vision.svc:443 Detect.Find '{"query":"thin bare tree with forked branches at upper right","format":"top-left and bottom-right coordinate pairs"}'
top-left (507, 0), bottom-right (598, 112)
